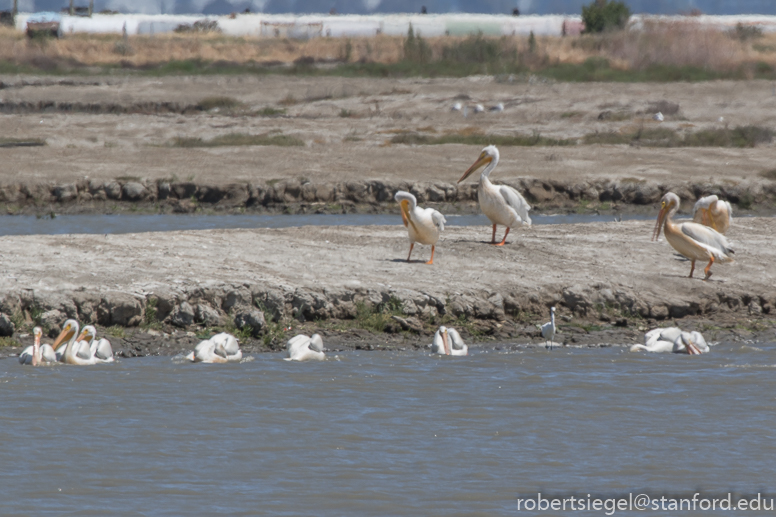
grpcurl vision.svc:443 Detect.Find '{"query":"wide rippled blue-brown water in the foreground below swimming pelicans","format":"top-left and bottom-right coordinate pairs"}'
top-left (0, 343), bottom-right (776, 516)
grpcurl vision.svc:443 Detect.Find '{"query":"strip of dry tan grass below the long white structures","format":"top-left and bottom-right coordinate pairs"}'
top-left (0, 22), bottom-right (776, 79)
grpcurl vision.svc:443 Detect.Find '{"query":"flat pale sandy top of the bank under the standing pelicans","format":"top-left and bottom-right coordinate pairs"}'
top-left (0, 218), bottom-right (776, 312)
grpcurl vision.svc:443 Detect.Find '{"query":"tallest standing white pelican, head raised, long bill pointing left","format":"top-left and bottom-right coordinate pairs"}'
top-left (458, 145), bottom-right (531, 246)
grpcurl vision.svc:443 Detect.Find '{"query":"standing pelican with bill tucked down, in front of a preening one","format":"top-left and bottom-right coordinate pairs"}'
top-left (652, 192), bottom-right (734, 280)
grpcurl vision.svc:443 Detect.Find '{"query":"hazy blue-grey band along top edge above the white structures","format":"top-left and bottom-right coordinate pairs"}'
top-left (10, 0), bottom-right (776, 15)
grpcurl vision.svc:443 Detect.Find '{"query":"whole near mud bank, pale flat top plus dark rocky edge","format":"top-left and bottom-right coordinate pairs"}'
top-left (0, 217), bottom-right (776, 355)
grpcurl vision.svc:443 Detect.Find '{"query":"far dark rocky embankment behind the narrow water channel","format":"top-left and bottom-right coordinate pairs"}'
top-left (0, 174), bottom-right (776, 213)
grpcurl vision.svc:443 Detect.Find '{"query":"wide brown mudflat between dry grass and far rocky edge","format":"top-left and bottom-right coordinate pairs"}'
top-left (0, 76), bottom-right (776, 184)
